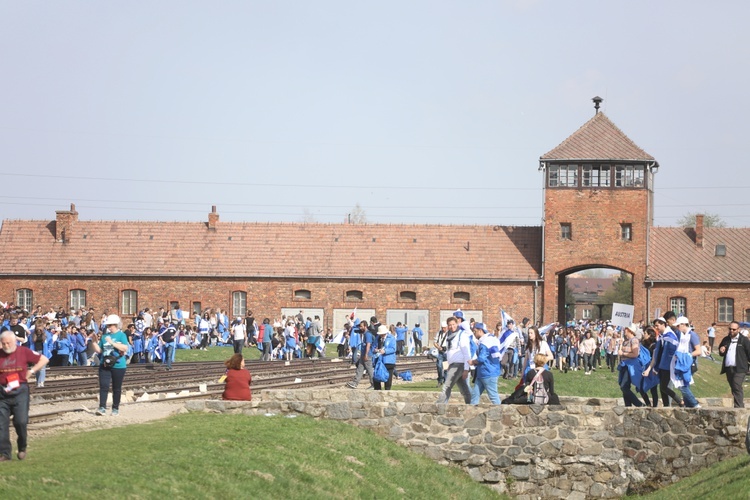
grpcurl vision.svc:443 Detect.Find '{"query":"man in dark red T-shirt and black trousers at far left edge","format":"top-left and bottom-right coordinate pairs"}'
top-left (0, 330), bottom-right (49, 462)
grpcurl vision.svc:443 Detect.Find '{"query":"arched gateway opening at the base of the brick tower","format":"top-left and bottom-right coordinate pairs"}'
top-left (557, 265), bottom-right (633, 324)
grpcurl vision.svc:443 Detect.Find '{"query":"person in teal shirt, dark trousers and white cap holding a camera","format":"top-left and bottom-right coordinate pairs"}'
top-left (93, 314), bottom-right (129, 417)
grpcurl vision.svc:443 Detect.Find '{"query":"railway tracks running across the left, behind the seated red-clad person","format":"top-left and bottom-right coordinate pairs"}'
top-left (29, 358), bottom-right (435, 423)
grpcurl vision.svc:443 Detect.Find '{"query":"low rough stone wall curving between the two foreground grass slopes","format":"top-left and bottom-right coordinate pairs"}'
top-left (186, 389), bottom-right (750, 499)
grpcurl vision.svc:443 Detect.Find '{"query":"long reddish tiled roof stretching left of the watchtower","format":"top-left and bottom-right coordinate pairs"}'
top-left (0, 220), bottom-right (541, 281)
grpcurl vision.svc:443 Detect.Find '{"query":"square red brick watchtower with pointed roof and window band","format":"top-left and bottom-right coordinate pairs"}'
top-left (539, 97), bottom-right (659, 323)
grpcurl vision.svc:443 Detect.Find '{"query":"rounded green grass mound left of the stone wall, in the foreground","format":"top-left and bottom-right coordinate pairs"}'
top-left (5, 413), bottom-right (506, 499)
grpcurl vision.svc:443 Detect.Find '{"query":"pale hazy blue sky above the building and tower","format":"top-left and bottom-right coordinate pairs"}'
top-left (0, 0), bottom-right (750, 227)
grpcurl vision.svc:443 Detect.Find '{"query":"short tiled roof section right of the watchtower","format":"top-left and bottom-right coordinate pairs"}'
top-left (649, 227), bottom-right (750, 283)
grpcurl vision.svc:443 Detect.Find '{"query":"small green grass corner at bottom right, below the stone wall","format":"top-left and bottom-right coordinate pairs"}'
top-left (638, 456), bottom-right (750, 500)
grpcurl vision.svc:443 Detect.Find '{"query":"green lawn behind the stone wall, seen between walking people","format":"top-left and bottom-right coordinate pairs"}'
top-left (394, 358), bottom-right (750, 398)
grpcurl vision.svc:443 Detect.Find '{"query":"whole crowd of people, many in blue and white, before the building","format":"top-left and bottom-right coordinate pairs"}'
top-left (0, 298), bottom-right (750, 461)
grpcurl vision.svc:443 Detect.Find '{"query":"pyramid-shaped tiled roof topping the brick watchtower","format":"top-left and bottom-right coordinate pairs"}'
top-left (540, 113), bottom-right (654, 161)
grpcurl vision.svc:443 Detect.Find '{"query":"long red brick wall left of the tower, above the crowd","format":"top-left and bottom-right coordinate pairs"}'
top-left (0, 278), bottom-right (534, 331)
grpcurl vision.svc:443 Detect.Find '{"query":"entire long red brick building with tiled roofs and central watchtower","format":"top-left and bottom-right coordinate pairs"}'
top-left (0, 105), bottom-right (750, 340)
